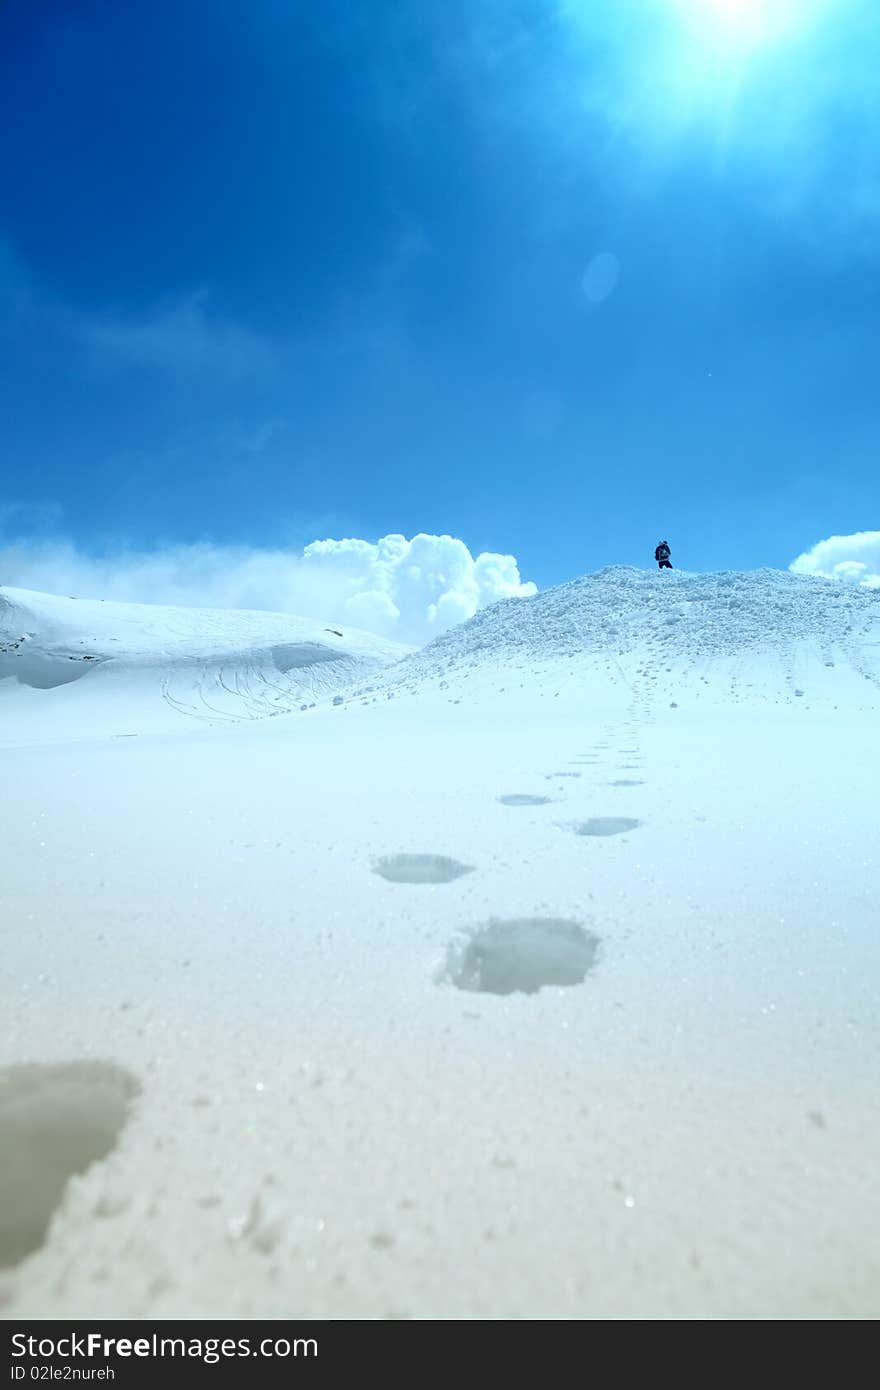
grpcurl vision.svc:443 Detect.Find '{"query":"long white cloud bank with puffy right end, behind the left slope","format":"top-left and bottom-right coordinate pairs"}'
top-left (0, 535), bottom-right (537, 644)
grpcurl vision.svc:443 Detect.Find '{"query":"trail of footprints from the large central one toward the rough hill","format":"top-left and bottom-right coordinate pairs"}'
top-left (373, 709), bottom-right (645, 994)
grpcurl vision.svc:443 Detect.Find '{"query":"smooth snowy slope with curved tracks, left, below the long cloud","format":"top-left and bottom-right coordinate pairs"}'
top-left (0, 588), bottom-right (407, 739)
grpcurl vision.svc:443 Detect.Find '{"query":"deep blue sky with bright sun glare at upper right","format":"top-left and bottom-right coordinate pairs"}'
top-left (0, 0), bottom-right (880, 587)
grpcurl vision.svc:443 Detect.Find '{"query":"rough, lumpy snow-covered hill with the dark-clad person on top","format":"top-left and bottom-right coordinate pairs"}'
top-left (367, 566), bottom-right (880, 703)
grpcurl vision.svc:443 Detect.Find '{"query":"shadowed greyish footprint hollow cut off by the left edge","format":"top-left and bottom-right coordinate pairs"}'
top-left (0, 1062), bottom-right (140, 1266)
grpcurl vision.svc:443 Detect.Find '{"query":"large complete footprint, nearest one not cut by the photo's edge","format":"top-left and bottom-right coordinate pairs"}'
top-left (442, 917), bottom-right (599, 994)
